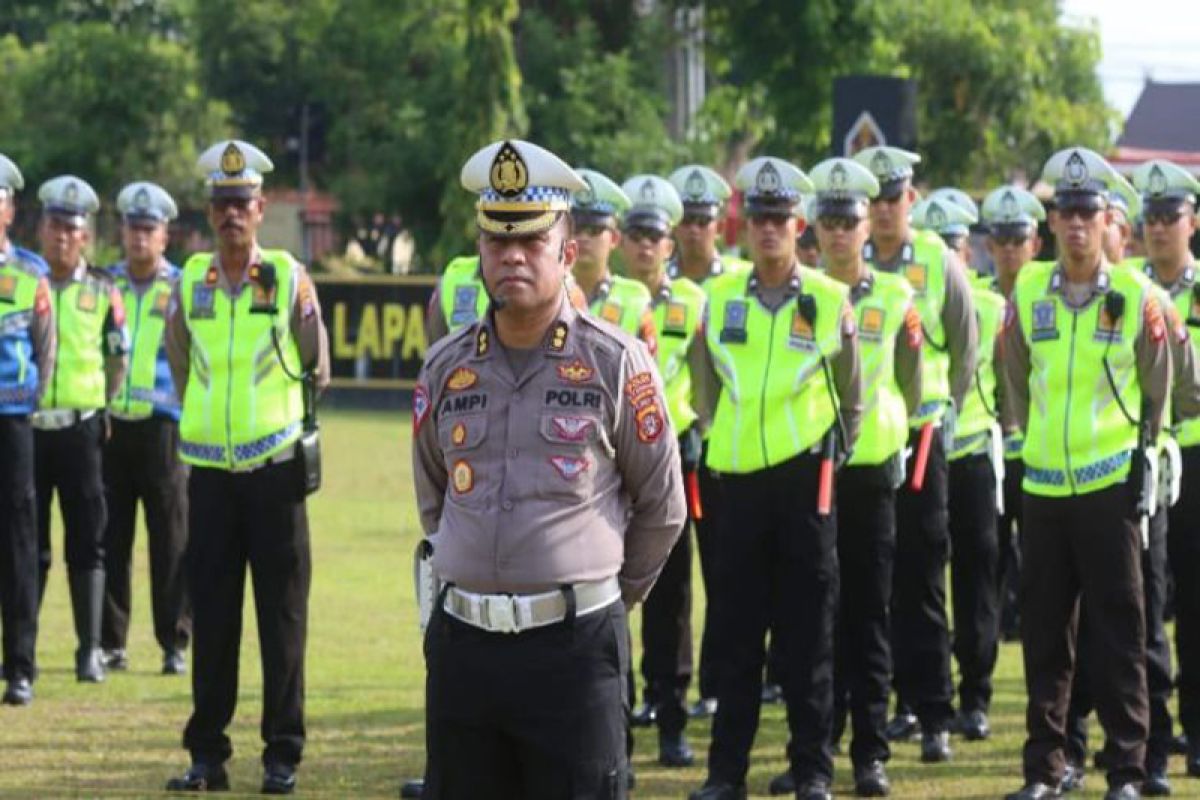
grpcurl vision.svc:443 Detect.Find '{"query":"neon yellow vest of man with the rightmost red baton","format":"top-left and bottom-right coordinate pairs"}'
top-left (866, 230), bottom-right (950, 428)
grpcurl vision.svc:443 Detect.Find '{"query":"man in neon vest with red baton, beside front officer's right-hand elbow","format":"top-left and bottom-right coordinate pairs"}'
top-left (620, 175), bottom-right (704, 766)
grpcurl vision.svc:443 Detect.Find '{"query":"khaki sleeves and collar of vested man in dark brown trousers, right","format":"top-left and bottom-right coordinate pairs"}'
top-left (1001, 257), bottom-right (1171, 438)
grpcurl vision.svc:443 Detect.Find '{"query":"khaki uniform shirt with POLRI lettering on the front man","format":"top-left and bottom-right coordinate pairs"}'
top-left (413, 294), bottom-right (686, 603)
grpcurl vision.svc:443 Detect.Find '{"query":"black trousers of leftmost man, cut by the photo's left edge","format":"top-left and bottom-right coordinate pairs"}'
top-left (0, 415), bottom-right (37, 680)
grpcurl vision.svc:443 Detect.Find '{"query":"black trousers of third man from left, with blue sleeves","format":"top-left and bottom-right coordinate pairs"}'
top-left (100, 417), bottom-right (192, 650)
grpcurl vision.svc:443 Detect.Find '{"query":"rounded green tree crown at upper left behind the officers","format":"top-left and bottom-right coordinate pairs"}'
top-left (0, 23), bottom-right (228, 209)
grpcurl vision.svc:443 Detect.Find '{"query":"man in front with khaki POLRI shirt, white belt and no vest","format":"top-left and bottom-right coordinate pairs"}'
top-left (413, 140), bottom-right (685, 800)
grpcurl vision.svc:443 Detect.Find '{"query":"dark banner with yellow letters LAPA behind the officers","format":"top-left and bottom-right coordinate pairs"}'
top-left (313, 275), bottom-right (437, 390)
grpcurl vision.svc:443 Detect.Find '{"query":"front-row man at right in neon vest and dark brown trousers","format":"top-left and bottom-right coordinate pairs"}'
top-left (1003, 148), bottom-right (1171, 800)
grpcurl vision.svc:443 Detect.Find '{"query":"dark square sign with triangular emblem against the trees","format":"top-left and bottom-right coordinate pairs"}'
top-left (830, 76), bottom-right (917, 156)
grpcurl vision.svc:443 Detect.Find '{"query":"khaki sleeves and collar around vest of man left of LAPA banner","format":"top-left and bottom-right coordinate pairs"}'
top-left (163, 246), bottom-right (329, 404)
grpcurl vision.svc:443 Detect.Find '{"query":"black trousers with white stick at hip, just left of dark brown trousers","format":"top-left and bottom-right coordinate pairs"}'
top-left (949, 453), bottom-right (1000, 712)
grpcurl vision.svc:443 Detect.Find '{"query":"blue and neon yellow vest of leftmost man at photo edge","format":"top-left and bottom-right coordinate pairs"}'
top-left (0, 261), bottom-right (40, 416)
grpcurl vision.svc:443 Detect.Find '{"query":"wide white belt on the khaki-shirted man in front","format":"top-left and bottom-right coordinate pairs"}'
top-left (443, 576), bottom-right (620, 633)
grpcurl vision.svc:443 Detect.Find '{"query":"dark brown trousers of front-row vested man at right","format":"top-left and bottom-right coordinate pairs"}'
top-left (1021, 485), bottom-right (1150, 784)
